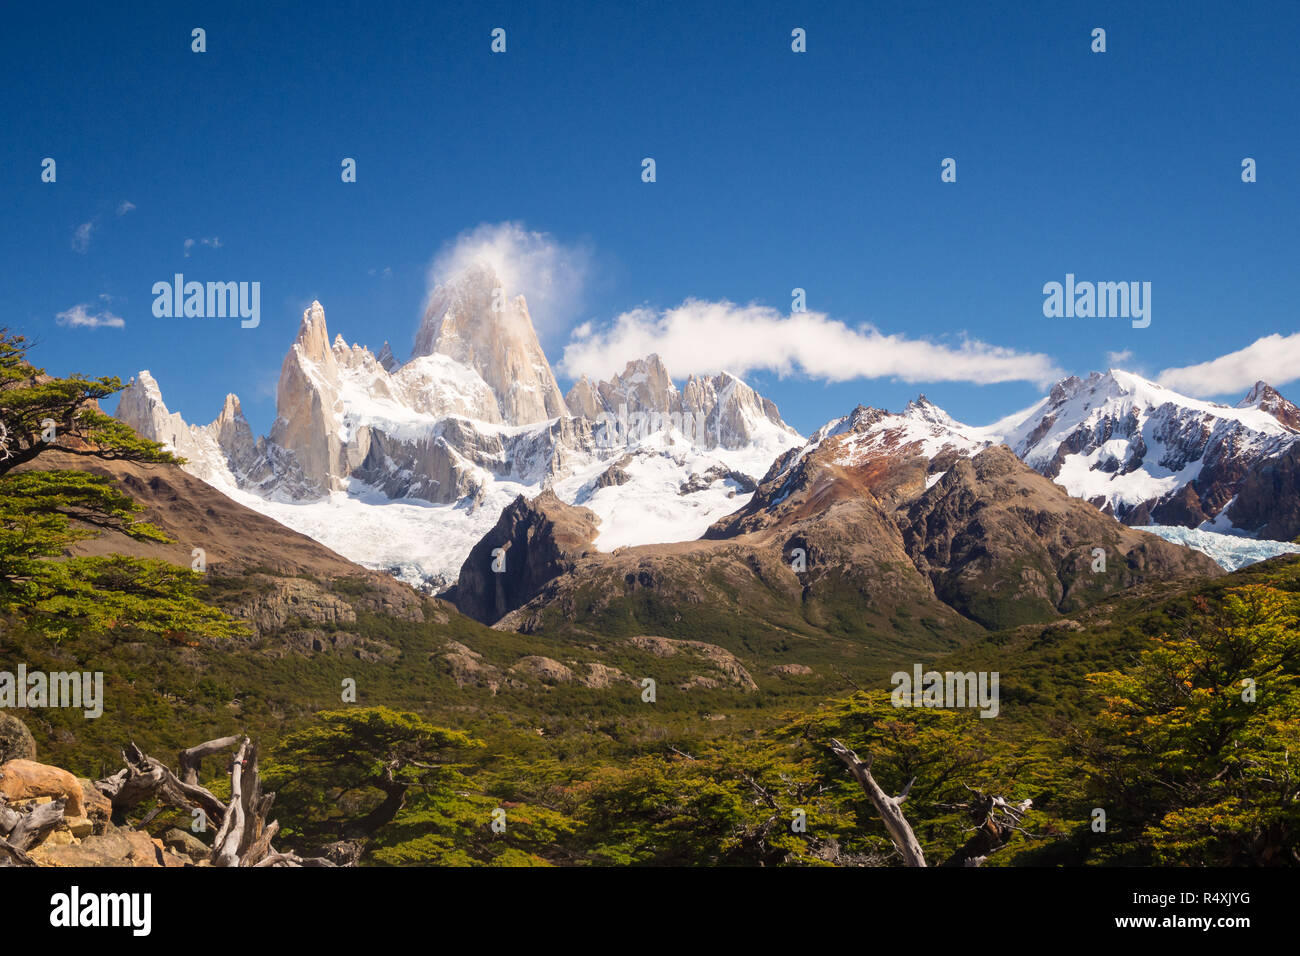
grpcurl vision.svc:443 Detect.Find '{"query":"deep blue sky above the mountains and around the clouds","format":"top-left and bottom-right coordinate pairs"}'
top-left (0, 0), bottom-right (1300, 433)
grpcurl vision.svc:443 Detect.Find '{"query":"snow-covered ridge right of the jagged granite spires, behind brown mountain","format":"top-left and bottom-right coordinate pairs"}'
top-left (743, 369), bottom-right (1300, 568)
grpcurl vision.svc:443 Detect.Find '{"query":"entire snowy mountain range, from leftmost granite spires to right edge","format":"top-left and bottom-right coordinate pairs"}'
top-left (117, 264), bottom-right (1300, 588)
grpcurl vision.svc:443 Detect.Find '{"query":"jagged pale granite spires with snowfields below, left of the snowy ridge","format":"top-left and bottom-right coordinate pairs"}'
top-left (117, 267), bottom-right (803, 589)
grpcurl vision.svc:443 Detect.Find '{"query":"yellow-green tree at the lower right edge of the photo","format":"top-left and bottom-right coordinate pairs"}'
top-left (1079, 584), bottom-right (1300, 866)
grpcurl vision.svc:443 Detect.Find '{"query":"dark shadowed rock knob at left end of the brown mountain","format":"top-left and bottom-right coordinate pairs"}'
top-left (454, 492), bottom-right (597, 624)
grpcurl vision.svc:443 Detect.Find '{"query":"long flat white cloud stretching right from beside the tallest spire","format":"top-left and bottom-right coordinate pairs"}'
top-left (559, 299), bottom-right (1062, 386)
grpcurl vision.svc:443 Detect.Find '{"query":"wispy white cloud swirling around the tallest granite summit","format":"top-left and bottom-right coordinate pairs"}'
top-left (429, 222), bottom-right (592, 337)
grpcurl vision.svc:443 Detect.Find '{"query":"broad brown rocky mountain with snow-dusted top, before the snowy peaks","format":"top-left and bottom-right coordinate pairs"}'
top-left (497, 398), bottom-right (1222, 641)
